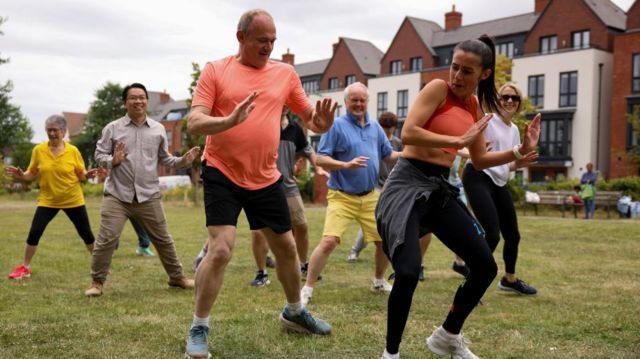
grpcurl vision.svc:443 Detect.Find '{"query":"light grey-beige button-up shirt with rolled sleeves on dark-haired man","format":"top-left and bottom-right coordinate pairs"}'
top-left (95, 115), bottom-right (182, 203)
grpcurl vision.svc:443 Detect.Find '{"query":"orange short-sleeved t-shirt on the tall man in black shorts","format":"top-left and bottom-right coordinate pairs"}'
top-left (191, 56), bottom-right (311, 190)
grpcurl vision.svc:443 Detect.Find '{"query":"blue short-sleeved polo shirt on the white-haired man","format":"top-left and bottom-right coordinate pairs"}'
top-left (318, 112), bottom-right (392, 193)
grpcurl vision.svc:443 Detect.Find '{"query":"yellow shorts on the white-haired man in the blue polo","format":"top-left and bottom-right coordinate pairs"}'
top-left (322, 189), bottom-right (382, 242)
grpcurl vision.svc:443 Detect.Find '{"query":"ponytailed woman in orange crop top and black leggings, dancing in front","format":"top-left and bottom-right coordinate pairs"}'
top-left (376, 35), bottom-right (540, 359)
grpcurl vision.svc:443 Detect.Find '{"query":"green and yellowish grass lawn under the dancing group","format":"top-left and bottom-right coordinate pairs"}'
top-left (0, 196), bottom-right (640, 359)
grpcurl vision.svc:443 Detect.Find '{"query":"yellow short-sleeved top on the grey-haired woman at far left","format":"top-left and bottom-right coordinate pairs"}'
top-left (29, 141), bottom-right (85, 208)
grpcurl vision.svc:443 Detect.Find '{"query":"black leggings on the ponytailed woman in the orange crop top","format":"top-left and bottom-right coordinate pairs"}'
top-left (387, 184), bottom-right (498, 353)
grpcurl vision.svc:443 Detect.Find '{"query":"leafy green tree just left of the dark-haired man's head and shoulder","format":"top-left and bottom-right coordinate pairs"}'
top-left (72, 82), bottom-right (125, 168)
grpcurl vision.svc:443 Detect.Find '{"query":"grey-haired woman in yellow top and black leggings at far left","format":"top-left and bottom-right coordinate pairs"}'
top-left (5, 115), bottom-right (105, 279)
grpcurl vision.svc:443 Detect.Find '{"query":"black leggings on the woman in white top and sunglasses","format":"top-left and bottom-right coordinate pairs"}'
top-left (462, 165), bottom-right (520, 274)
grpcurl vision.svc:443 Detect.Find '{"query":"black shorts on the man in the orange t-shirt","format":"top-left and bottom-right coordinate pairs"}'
top-left (202, 163), bottom-right (291, 234)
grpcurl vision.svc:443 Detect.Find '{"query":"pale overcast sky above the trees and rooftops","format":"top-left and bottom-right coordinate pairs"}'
top-left (0, 0), bottom-right (633, 142)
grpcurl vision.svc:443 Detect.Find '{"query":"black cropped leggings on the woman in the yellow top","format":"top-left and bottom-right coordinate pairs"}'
top-left (27, 206), bottom-right (95, 246)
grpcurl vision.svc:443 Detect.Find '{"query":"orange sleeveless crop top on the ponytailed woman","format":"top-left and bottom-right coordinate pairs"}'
top-left (423, 87), bottom-right (478, 155)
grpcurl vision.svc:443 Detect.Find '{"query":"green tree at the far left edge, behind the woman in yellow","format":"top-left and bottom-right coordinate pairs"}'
top-left (0, 17), bottom-right (33, 168)
